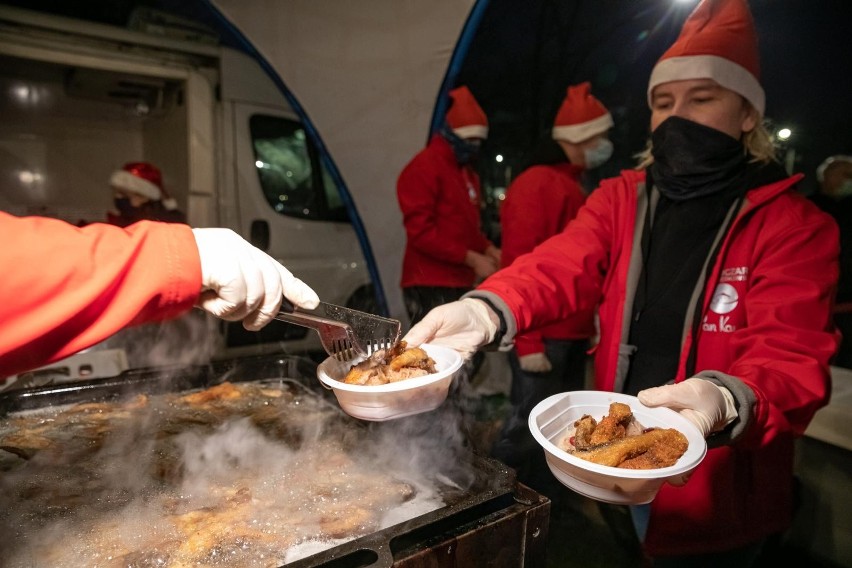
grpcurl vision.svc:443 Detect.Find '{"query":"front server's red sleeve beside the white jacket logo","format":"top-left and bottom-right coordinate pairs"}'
top-left (724, 202), bottom-right (840, 444)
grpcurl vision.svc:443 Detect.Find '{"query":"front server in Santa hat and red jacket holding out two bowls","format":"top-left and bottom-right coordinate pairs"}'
top-left (405, 0), bottom-right (839, 568)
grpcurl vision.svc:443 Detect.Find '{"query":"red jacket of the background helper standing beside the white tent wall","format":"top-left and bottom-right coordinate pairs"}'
top-left (396, 134), bottom-right (492, 288)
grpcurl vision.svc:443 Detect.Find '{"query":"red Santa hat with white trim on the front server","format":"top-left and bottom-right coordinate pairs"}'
top-left (648, 0), bottom-right (766, 116)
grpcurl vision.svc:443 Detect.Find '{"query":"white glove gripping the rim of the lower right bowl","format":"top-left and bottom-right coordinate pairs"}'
top-left (637, 377), bottom-right (737, 438)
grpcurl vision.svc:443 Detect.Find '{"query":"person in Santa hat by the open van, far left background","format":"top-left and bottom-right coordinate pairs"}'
top-left (107, 162), bottom-right (186, 227)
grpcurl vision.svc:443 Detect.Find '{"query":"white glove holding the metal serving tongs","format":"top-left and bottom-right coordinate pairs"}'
top-left (192, 229), bottom-right (319, 331)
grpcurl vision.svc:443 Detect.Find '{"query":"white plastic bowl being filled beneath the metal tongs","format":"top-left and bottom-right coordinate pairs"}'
top-left (317, 343), bottom-right (463, 422)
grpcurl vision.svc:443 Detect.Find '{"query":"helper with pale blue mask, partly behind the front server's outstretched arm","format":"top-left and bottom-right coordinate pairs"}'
top-left (491, 82), bottom-right (613, 510)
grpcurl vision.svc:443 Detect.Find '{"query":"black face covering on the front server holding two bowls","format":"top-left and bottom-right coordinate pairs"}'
top-left (650, 116), bottom-right (748, 201)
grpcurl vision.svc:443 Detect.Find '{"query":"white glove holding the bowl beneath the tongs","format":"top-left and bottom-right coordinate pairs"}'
top-left (403, 298), bottom-right (497, 359)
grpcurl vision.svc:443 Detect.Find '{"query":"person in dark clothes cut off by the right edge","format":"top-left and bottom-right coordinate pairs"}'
top-left (810, 155), bottom-right (852, 369)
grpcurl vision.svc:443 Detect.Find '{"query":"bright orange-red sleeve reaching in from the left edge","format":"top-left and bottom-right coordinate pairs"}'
top-left (0, 212), bottom-right (201, 377)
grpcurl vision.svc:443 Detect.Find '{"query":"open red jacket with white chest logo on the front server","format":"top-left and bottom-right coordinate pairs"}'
top-left (476, 171), bottom-right (839, 556)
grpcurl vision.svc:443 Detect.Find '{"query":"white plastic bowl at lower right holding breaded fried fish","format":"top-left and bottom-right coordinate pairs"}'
top-left (529, 391), bottom-right (707, 505)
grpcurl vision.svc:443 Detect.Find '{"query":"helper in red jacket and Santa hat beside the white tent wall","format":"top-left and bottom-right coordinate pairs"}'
top-left (396, 86), bottom-right (500, 324)
